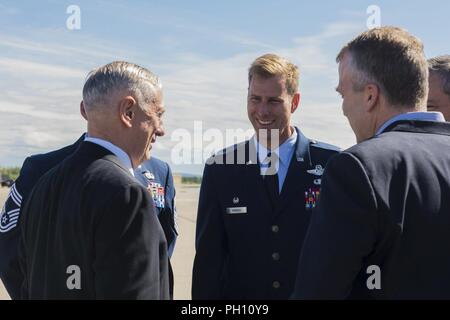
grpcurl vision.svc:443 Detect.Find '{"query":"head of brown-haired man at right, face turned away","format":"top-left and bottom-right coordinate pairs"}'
top-left (336, 27), bottom-right (428, 142)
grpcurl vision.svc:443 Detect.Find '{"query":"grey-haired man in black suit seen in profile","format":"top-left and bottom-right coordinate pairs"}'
top-left (11, 62), bottom-right (169, 299)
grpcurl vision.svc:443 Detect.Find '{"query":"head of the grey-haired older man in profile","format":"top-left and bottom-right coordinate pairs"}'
top-left (83, 61), bottom-right (164, 167)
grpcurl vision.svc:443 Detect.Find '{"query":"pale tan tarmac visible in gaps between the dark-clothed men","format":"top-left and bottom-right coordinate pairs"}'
top-left (0, 185), bottom-right (199, 300)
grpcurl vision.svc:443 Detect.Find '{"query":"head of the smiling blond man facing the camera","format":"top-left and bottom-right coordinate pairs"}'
top-left (247, 54), bottom-right (300, 148)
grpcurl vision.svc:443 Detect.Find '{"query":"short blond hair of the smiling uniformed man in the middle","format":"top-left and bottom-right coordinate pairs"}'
top-left (248, 53), bottom-right (299, 96)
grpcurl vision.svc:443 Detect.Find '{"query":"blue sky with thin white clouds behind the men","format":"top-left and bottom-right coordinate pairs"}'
top-left (0, 0), bottom-right (450, 173)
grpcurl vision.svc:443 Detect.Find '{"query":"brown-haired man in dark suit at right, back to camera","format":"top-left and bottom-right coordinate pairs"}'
top-left (293, 27), bottom-right (450, 299)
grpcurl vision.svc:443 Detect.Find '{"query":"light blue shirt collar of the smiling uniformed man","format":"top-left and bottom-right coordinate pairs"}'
top-left (253, 128), bottom-right (298, 193)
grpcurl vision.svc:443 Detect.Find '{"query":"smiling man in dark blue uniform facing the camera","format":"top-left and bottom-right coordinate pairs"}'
top-left (192, 54), bottom-right (338, 299)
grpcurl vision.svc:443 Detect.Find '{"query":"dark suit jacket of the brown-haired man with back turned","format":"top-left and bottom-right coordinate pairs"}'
top-left (293, 121), bottom-right (450, 299)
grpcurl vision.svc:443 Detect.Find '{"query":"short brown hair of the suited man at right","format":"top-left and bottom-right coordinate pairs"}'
top-left (336, 26), bottom-right (428, 108)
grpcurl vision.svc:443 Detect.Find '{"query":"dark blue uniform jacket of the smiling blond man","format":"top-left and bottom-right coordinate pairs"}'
top-left (192, 128), bottom-right (337, 299)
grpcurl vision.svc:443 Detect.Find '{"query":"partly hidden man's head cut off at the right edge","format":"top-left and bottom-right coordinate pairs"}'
top-left (428, 55), bottom-right (450, 121)
